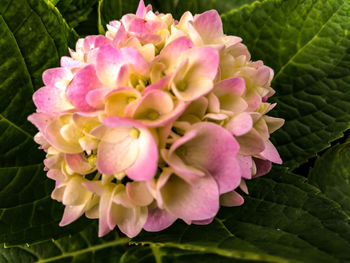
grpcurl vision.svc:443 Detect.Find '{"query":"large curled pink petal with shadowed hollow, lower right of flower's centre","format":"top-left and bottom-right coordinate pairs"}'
top-left (169, 122), bottom-right (241, 193)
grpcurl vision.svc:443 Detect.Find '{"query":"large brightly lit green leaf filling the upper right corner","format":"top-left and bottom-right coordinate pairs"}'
top-left (222, 0), bottom-right (350, 168)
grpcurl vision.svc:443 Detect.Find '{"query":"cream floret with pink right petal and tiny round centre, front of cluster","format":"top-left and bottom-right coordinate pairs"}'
top-left (91, 117), bottom-right (158, 181)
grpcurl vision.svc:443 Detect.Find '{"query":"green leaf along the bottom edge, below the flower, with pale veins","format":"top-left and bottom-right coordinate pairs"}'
top-left (0, 224), bottom-right (268, 263)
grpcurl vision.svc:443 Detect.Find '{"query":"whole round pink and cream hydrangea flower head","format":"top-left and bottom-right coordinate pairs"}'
top-left (28, 0), bottom-right (283, 237)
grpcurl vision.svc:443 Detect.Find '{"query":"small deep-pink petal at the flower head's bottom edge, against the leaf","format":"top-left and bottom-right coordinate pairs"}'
top-left (143, 208), bottom-right (177, 232)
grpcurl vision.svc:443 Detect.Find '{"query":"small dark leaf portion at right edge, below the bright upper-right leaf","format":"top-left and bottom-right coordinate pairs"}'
top-left (308, 143), bottom-right (350, 217)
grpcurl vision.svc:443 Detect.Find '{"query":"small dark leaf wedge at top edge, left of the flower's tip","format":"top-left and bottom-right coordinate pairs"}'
top-left (50, 0), bottom-right (98, 28)
